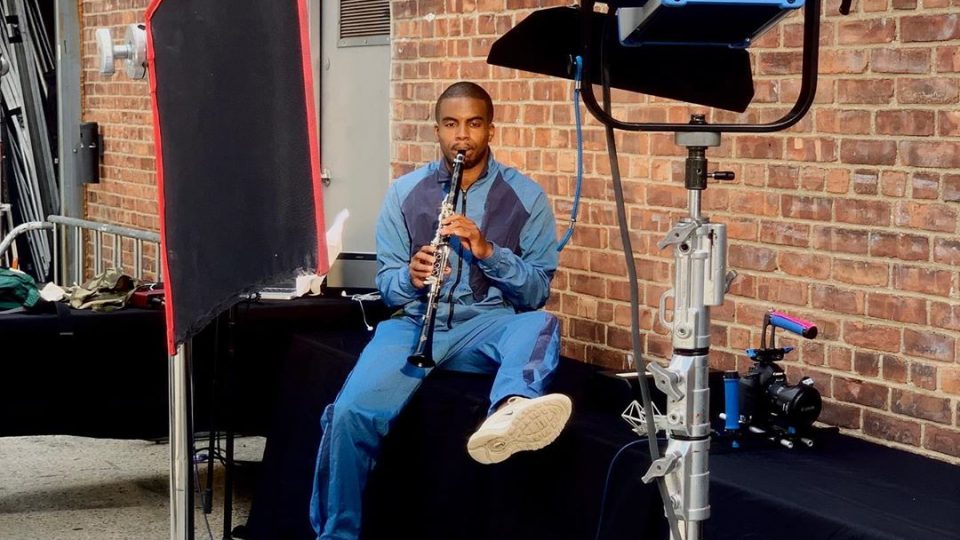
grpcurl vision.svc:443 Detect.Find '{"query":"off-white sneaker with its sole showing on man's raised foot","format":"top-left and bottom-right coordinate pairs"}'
top-left (467, 394), bottom-right (571, 465)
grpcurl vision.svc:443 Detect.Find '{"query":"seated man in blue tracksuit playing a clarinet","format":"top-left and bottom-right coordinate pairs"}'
top-left (310, 82), bottom-right (571, 540)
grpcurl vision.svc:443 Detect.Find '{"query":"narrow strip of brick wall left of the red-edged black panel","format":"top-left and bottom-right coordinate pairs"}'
top-left (80, 0), bottom-right (160, 272)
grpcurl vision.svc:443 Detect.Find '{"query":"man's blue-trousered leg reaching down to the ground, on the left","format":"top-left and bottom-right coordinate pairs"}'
top-left (310, 319), bottom-right (422, 540)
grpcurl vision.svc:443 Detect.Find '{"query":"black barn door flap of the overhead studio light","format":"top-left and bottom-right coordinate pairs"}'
top-left (487, 7), bottom-right (753, 112)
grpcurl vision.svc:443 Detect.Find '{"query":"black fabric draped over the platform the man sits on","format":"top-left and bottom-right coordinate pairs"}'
top-left (238, 336), bottom-right (960, 540)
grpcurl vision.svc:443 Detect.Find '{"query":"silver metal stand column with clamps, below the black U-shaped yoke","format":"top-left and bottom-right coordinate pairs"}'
top-left (643, 115), bottom-right (735, 540)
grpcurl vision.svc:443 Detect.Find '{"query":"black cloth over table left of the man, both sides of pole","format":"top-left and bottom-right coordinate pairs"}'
top-left (0, 298), bottom-right (385, 439)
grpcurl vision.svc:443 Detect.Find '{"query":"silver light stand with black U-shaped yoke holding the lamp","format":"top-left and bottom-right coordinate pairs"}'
top-left (564, 0), bottom-right (832, 540)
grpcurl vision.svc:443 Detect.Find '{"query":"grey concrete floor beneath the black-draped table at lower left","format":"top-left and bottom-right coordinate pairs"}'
top-left (0, 436), bottom-right (265, 540)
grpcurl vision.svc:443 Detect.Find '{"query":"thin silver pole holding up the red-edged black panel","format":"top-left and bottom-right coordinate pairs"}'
top-left (169, 343), bottom-right (193, 540)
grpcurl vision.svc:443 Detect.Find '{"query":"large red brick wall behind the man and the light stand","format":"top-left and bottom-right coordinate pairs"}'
top-left (392, 0), bottom-right (960, 463)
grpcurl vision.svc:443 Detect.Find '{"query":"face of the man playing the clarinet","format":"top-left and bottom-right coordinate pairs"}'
top-left (436, 97), bottom-right (493, 170)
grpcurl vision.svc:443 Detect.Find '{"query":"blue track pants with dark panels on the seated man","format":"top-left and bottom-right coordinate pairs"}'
top-left (310, 311), bottom-right (560, 540)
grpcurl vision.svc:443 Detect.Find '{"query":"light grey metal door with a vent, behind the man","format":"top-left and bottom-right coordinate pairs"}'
top-left (311, 0), bottom-right (390, 251)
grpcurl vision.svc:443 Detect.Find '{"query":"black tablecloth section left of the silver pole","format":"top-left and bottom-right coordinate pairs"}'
top-left (0, 309), bottom-right (169, 438)
